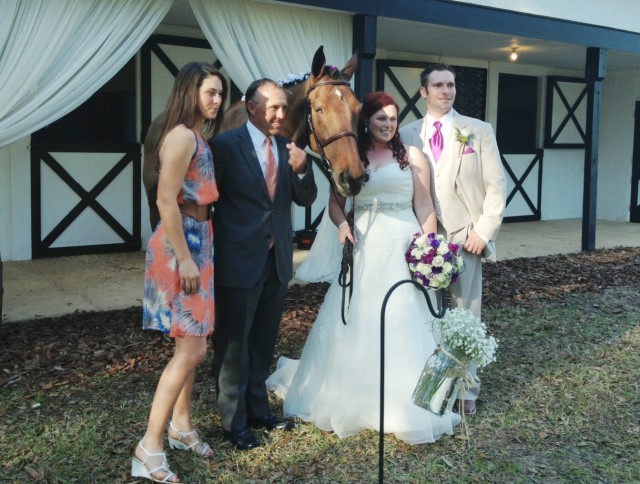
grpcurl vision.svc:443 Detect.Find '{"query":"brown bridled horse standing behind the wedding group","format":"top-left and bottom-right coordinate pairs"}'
top-left (143, 46), bottom-right (364, 227)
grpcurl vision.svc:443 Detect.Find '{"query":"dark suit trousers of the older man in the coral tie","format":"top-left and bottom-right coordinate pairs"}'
top-left (213, 249), bottom-right (287, 431)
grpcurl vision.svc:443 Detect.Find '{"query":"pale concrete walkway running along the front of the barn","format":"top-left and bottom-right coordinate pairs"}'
top-left (2, 219), bottom-right (640, 323)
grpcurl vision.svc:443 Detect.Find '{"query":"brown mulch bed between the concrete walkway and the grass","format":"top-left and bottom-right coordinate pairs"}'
top-left (0, 248), bottom-right (640, 390)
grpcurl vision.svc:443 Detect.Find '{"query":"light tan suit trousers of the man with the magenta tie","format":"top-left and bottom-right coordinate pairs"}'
top-left (450, 251), bottom-right (482, 400)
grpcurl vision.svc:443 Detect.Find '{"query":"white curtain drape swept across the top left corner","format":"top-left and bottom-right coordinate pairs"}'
top-left (0, 0), bottom-right (173, 147)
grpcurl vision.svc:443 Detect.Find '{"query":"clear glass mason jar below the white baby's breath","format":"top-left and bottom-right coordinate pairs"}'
top-left (413, 346), bottom-right (467, 415)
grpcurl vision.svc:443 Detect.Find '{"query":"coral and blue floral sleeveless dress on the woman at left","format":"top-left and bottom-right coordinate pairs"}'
top-left (142, 131), bottom-right (218, 337)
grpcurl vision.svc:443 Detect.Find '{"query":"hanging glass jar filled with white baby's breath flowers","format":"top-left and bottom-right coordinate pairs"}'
top-left (413, 309), bottom-right (498, 415)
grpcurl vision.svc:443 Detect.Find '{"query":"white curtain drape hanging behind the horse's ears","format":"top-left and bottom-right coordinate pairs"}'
top-left (189, 0), bottom-right (353, 92)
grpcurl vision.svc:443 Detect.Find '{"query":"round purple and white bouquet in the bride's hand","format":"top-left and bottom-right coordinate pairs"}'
top-left (405, 233), bottom-right (464, 289)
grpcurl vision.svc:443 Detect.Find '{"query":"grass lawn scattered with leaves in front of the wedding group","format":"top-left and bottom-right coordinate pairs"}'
top-left (0, 286), bottom-right (640, 483)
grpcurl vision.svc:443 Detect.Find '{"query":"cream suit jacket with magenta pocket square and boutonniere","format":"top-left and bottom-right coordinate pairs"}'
top-left (400, 111), bottom-right (506, 262)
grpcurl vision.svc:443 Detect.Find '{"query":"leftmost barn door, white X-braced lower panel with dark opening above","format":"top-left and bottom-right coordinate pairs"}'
top-left (31, 59), bottom-right (141, 258)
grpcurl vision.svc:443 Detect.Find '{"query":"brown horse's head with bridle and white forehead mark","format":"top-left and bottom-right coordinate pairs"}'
top-left (292, 46), bottom-right (364, 196)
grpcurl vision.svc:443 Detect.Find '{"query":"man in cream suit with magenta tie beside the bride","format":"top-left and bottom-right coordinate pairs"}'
top-left (400, 64), bottom-right (506, 415)
